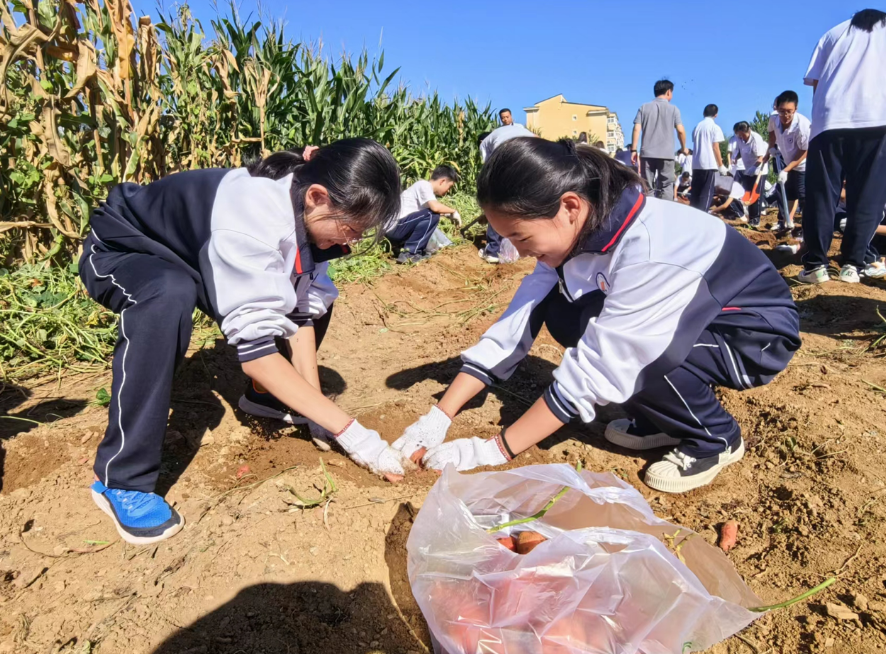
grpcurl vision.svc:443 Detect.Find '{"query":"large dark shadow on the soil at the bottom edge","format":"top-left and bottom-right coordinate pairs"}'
top-left (153, 581), bottom-right (423, 654)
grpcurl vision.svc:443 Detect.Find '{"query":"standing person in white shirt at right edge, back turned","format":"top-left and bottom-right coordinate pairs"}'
top-left (799, 9), bottom-right (886, 284)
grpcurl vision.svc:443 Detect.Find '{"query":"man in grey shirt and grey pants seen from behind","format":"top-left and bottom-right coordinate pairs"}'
top-left (631, 79), bottom-right (689, 201)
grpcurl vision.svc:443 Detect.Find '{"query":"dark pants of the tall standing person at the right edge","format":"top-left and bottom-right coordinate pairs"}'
top-left (803, 127), bottom-right (886, 270)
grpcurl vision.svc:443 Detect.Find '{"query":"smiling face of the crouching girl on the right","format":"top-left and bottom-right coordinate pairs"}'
top-left (486, 192), bottom-right (590, 268)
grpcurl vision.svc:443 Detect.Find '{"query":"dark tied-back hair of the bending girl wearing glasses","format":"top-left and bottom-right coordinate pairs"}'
top-left (247, 138), bottom-right (400, 240)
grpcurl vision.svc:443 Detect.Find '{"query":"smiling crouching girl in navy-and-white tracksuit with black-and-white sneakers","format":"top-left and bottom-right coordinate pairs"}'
top-left (393, 138), bottom-right (800, 492)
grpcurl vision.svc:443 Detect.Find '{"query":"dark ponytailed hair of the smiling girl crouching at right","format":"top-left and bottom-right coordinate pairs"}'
top-left (477, 137), bottom-right (643, 253)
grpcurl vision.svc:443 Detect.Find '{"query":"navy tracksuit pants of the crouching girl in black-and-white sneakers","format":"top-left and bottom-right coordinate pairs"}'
top-left (531, 288), bottom-right (800, 458)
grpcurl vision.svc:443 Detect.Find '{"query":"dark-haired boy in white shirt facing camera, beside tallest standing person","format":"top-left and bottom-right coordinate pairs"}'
top-left (767, 91), bottom-right (812, 232)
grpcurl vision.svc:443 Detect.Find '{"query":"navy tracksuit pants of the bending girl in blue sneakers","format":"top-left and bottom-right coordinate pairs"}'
top-left (80, 236), bottom-right (331, 493)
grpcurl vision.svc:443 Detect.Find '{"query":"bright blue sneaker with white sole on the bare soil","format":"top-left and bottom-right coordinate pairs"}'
top-left (90, 481), bottom-right (185, 545)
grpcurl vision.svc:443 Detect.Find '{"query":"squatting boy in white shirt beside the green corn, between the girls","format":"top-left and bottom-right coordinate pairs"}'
top-left (387, 166), bottom-right (461, 263)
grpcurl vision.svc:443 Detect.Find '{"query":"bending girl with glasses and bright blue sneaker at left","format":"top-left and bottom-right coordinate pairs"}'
top-left (80, 139), bottom-right (403, 544)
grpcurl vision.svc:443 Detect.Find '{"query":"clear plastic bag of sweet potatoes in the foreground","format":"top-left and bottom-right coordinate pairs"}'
top-left (406, 464), bottom-right (762, 654)
